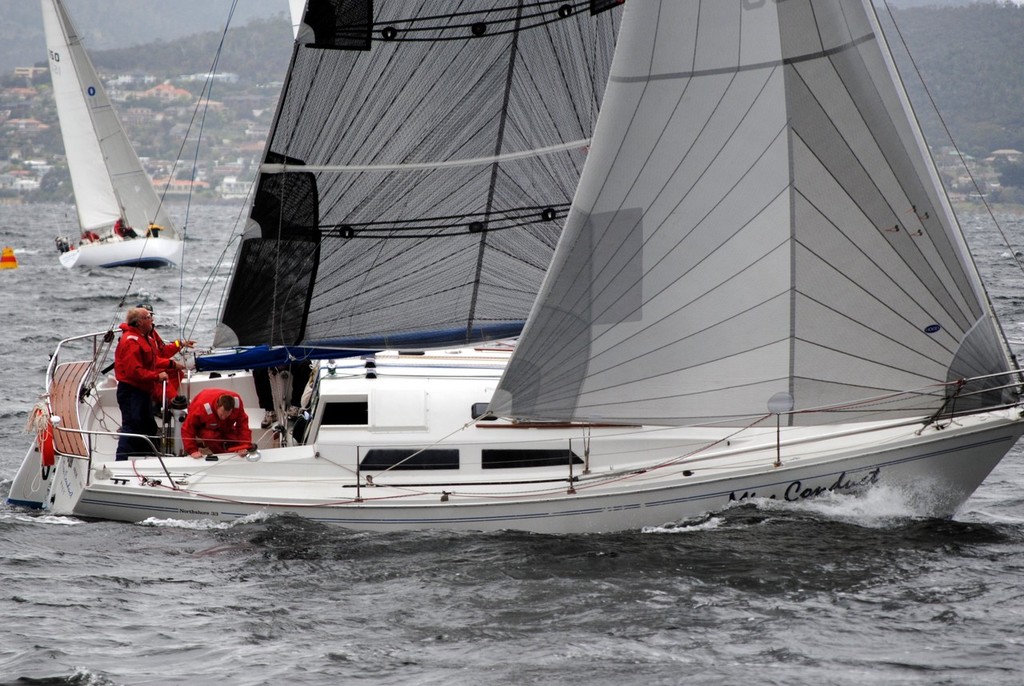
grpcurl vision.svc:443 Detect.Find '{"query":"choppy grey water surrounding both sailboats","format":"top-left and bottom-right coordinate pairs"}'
top-left (0, 206), bottom-right (1024, 686)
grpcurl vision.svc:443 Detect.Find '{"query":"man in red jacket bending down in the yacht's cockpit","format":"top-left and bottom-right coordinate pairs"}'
top-left (181, 388), bottom-right (253, 458)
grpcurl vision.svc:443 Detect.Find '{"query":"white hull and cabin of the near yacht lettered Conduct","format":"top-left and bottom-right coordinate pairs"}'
top-left (10, 346), bottom-right (1024, 532)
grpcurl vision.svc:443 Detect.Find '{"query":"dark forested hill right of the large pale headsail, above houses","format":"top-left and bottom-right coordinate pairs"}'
top-left (879, 3), bottom-right (1024, 156)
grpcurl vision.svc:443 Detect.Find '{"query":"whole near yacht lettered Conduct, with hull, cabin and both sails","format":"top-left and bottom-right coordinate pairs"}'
top-left (10, 0), bottom-right (1024, 532)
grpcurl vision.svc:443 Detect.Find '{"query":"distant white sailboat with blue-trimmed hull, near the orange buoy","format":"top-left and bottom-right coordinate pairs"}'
top-left (41, 0), bottom-right (182, 267)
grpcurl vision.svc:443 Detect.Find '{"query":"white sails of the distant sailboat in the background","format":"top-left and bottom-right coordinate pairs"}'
top-left (42, 0), bottom-right (177, 238)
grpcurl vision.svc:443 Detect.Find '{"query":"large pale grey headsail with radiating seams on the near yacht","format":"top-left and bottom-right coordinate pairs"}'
top-left (492, 0), bottom-right (1009, 424)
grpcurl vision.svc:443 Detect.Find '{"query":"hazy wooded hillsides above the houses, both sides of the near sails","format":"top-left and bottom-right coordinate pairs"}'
top-left (8, 0), bottom-right (1024, 156)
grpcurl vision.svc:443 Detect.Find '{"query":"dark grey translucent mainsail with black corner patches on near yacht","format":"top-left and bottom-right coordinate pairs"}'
top-left (215, 0), bottom-right (621, 349)
